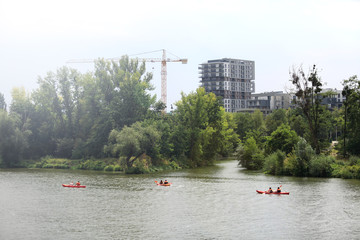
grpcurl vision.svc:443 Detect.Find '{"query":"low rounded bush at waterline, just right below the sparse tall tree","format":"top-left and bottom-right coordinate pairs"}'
top-left (309, 155), bottom-right (335, 177)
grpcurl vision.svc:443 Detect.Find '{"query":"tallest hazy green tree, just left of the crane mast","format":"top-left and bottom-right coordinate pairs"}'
top-left (79, 56), bottom-right (156, 157)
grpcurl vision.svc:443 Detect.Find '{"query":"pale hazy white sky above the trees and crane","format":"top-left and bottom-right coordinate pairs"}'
top-left (0, 0), bottom-right (360, 109)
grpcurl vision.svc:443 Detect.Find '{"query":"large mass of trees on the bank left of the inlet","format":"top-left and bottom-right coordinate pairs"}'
top-left (0, 56), bottom-right (237, 169)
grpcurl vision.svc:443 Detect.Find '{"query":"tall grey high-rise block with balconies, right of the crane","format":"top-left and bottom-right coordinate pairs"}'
top-left (199, 58), bottom-right (255, 112)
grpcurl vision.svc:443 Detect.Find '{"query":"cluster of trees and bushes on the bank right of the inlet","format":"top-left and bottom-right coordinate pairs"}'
top-left (235, 66), bottom-right (360, 178)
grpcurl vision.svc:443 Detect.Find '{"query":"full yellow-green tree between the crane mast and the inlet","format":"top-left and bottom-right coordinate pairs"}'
top-left (174, 88), bottom-right (225, 167)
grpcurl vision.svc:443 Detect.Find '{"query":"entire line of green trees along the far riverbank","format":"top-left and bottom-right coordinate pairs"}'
top-left (0, 59), bottom-right (360, 176)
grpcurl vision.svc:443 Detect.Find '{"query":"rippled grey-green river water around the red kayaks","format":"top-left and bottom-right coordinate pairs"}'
top-left (0, 161), bottom-right (360, 240)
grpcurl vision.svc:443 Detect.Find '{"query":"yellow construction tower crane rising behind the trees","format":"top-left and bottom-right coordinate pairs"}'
top-left (67, 49), bottom-right (188, 109)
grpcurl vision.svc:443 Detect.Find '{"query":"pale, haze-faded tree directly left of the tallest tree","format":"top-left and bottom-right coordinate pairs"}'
top-left (30, 67), bottom-right (81, 158)
